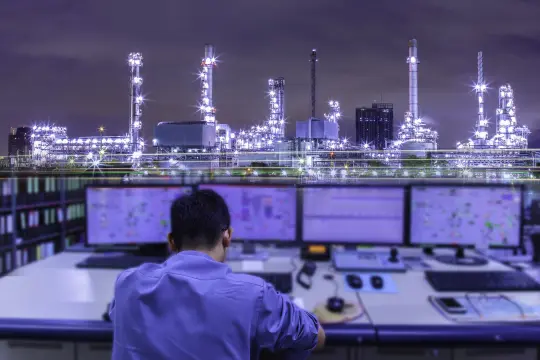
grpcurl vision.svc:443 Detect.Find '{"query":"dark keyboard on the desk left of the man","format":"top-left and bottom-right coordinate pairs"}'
top-left (77, 254), bottom-right (166, 270)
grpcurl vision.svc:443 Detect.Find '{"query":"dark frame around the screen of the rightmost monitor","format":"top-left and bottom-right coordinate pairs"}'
top-left (407, 182), bottom-right (525, 249)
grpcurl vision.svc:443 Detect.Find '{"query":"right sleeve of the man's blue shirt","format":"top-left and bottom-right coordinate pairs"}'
top-left (255, 284), bottom-right (319, 353)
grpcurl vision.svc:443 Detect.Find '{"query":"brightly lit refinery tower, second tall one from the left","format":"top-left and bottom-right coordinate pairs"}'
top-left (199, 44), bottom-right (216, 124)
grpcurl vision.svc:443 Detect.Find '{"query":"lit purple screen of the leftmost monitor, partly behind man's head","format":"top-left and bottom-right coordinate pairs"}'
top-left (86, 186), bottom-right (191, 245)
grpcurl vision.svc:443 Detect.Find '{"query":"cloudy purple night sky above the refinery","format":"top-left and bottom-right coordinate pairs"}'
top-left (0, 0), bottom-right (540, 154)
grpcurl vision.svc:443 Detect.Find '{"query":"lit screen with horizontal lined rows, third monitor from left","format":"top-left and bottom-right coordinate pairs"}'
top-left (302, 187), bottom-right (405, 245)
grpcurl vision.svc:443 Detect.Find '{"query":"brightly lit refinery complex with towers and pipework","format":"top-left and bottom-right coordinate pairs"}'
top-left (11, 39), bottom-right (536, 180)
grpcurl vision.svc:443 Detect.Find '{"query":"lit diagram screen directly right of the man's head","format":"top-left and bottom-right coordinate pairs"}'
top-left (199, 184), bottom-right (296, 241)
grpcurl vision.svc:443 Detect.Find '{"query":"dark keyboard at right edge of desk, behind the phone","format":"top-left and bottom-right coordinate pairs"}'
top-left (425, 271), bottom-right (540, 292)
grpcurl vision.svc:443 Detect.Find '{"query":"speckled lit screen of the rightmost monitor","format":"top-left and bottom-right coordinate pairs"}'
top-left (411, 186), bottom-right (522, 247)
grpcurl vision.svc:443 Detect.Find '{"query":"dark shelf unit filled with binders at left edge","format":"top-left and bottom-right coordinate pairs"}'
top-left (0, 176), bottom-right (96, 276)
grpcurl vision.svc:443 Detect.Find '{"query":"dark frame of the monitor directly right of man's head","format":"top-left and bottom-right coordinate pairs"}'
top-left (195, 182), bottom-right (301, 248)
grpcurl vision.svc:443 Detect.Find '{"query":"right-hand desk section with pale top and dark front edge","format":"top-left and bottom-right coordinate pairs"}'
top-left (361, 249), bottom-right (540, 346)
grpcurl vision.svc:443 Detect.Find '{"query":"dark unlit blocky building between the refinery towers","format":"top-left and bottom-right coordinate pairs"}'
top-left (356, 103), bottom-right (394, 150)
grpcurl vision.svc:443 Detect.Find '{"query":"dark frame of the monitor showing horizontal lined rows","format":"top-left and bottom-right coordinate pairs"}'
top-left (298, 184), bottom-right (409, 248)
